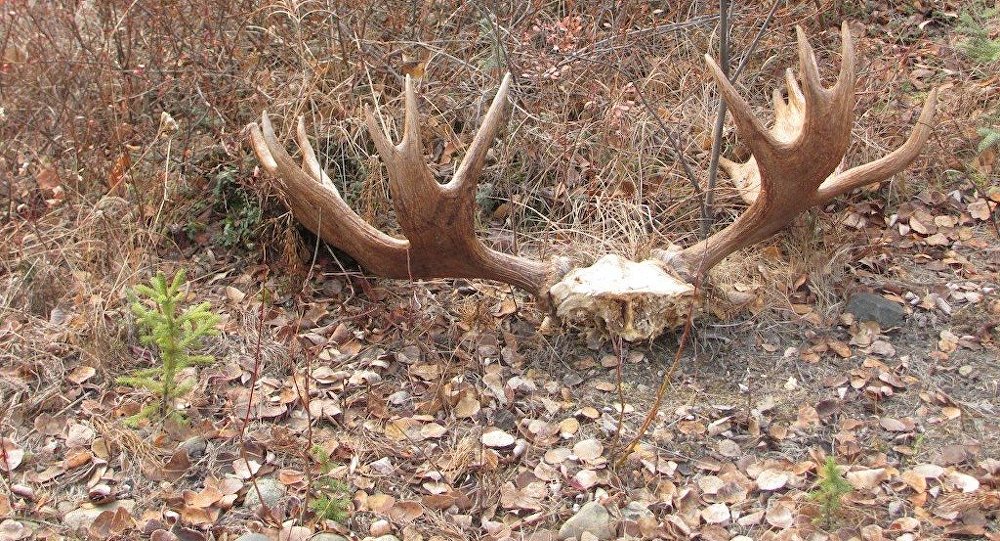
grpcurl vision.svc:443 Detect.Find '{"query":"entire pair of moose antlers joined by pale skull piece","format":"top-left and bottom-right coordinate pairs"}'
top-left (250, 23), bottom-right (937, 340)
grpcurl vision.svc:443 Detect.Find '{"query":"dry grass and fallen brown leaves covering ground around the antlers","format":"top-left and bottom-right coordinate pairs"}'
top-left (0, 0), bottom-right (1000, 541)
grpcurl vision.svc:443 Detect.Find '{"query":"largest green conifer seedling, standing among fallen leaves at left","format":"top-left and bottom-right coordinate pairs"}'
top-left (117, 269), bottom-right (219, 427)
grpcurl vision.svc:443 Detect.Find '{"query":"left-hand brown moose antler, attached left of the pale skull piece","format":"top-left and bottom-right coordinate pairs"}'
top-left (250, 74), bottom-right (558, 296)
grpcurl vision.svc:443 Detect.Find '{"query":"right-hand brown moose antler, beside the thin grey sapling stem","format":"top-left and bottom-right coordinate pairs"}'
top-left (671, 22), bottom-right (937, 274)
